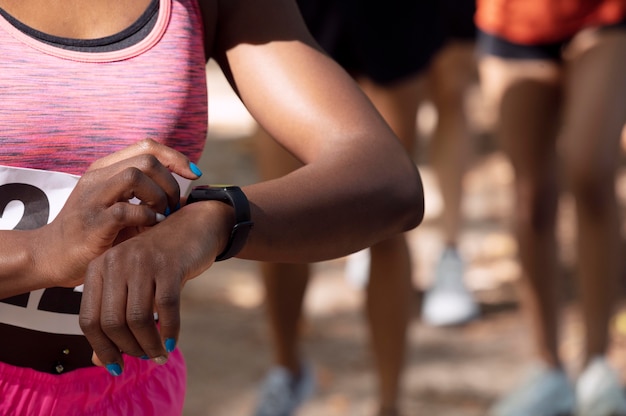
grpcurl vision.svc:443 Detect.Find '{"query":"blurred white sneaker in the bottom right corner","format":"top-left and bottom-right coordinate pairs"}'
top-left (576, 357), bottom-right (626, 416)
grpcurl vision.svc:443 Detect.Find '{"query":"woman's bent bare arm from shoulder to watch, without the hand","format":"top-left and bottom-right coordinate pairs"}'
top-left (215, 0), bottom-right (424, 262)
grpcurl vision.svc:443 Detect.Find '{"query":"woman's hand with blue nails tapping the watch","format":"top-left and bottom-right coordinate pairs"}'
top-left (37, 140), bottom-right (199, 287)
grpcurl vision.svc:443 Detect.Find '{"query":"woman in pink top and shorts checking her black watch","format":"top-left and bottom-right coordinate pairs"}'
top-left (0, 0), bottom-right (423, 416)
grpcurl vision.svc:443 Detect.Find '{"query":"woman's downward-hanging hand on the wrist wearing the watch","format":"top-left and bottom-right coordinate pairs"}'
top-left (79, 202), bottom-right (233, 375)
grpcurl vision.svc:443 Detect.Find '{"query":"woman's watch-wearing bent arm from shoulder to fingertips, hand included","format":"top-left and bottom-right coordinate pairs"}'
top-left (75, 0), bottom-right (424, 375)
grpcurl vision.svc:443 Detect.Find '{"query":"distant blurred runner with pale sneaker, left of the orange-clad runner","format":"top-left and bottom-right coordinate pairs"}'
top-left (421, 0), bottom-right (479, 326)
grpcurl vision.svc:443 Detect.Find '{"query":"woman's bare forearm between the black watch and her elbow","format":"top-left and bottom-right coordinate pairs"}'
top-left (239, 148), bottom-right (424, 262)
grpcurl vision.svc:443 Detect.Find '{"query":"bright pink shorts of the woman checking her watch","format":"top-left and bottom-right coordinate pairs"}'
top-left (0, 350), bottom-right (187, 416)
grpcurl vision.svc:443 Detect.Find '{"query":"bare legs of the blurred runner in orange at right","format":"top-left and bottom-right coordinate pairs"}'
top-left (480, 29), bottom-right (626, 376)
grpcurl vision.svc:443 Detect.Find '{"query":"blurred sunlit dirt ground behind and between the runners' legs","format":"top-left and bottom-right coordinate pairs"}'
top-left (174, 61), bottom-right (626, 416)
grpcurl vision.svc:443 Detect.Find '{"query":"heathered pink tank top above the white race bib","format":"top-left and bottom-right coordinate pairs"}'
top-left (0, 0), bottom-right (207, 175)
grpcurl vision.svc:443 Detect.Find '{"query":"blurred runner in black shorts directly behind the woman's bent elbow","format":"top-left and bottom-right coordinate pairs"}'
top-left (255, 0), bottom-right (442, 416)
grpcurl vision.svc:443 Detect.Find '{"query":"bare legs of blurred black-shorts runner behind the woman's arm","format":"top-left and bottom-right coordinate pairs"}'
top-left (254, 73), bottom-right (424, 415)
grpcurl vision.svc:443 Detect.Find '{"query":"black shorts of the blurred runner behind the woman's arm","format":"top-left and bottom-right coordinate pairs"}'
top-left (298, 0), bottom-right (444, 84)
